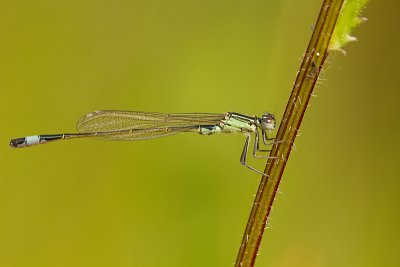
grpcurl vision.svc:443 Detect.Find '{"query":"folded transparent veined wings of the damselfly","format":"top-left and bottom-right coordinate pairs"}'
top-left (76, 110), bottom-right (225, 140)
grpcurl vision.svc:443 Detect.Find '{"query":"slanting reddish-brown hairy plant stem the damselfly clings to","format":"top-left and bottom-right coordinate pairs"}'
top-left (235, 0), bottom-right (344, 267)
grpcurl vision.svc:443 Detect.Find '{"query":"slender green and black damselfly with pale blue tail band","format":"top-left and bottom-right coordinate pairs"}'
top-left (10, 110), bottom-right (275, 175)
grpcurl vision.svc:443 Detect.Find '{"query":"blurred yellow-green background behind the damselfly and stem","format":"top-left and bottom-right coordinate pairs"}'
top-left (0, 0), bottom-right (400, 267)
